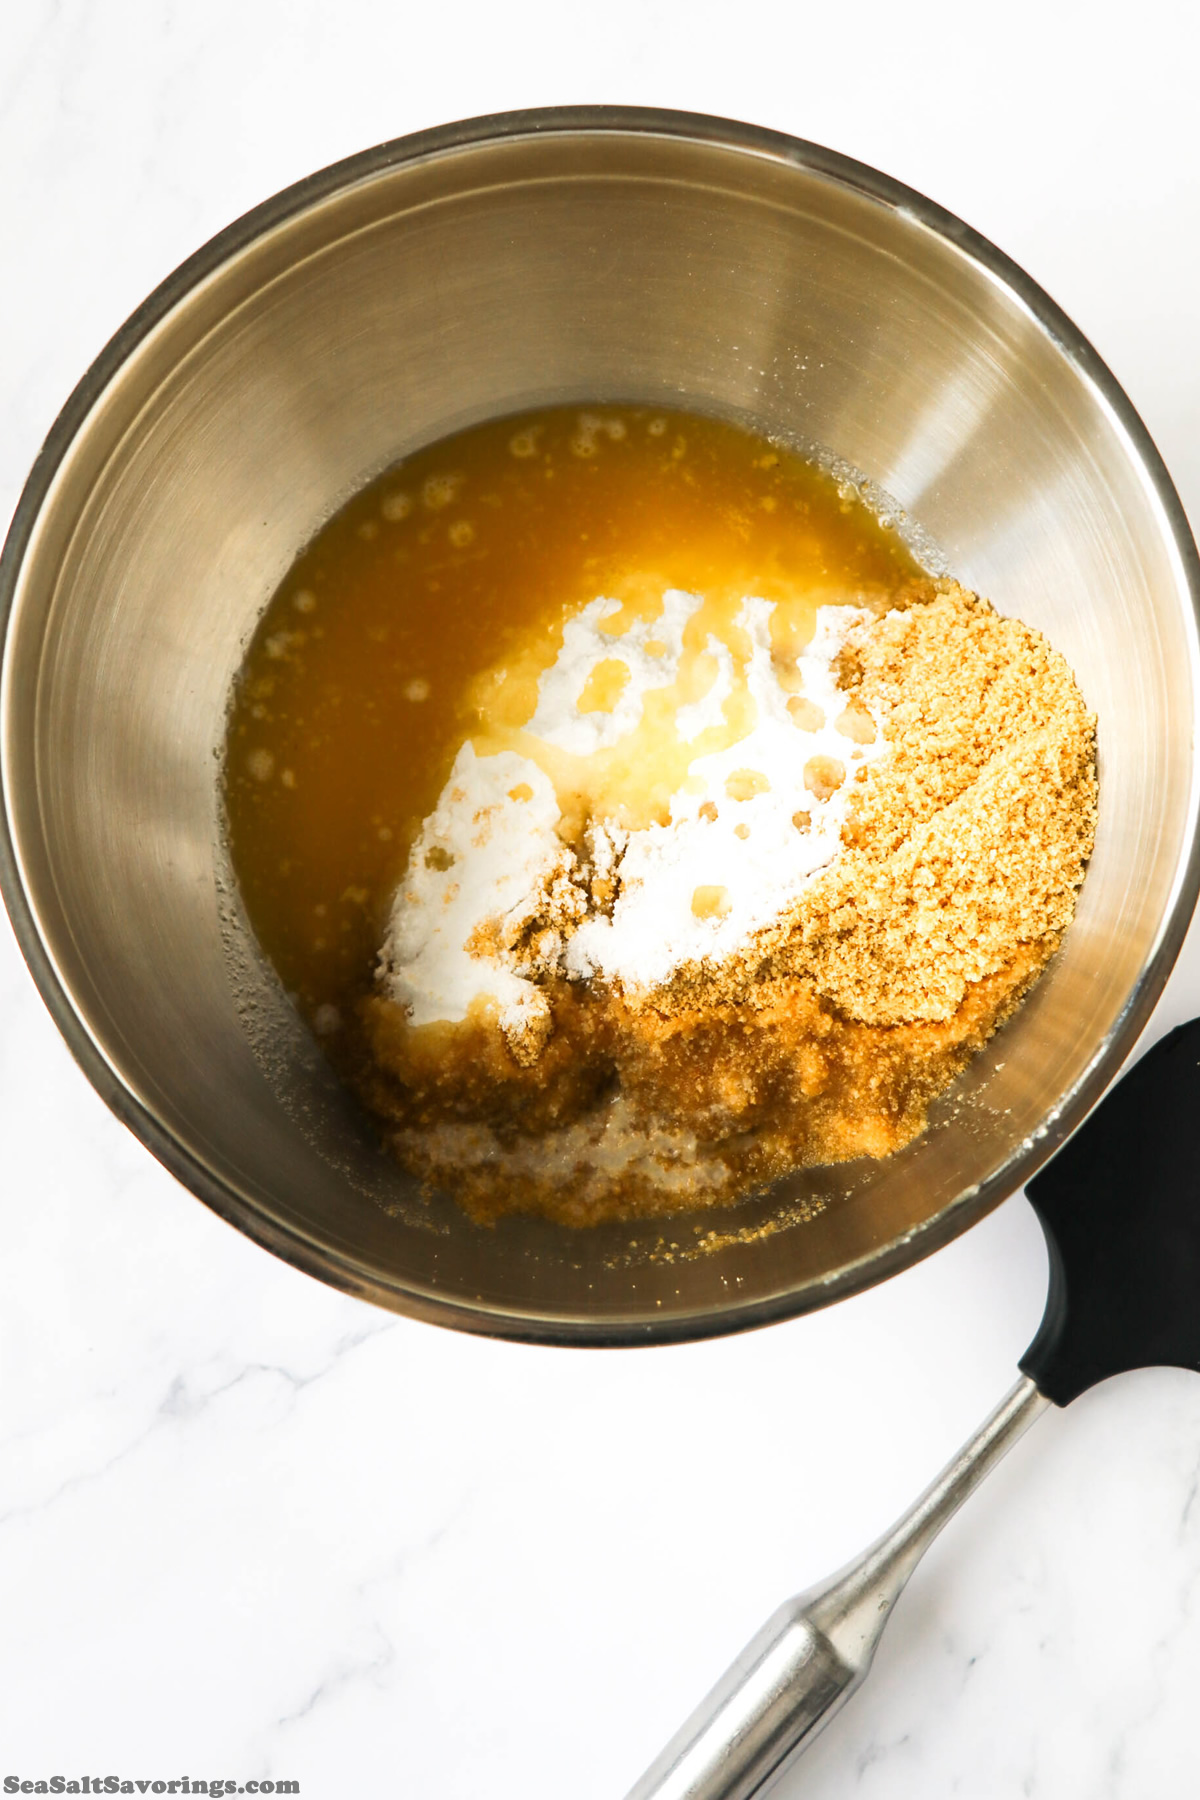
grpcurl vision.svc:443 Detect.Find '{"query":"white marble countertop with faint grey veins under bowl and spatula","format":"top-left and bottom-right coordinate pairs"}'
top-left (0, 0), bottom-right (1200, 1800)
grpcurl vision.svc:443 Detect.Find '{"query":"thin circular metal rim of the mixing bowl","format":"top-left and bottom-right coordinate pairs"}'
top-left (0, 106), bottom-right (1200, 1346)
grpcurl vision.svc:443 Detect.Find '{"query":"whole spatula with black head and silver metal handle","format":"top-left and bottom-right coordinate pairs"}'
top-left (628, 1019), bottom-right (1200, 1800)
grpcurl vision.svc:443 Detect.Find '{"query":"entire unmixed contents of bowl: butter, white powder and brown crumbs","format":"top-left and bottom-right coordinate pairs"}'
top-left (227, 409), bottom-right (1096, 1224)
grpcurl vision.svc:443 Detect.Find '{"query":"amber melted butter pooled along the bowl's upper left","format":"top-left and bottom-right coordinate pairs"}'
top-left (225, 407), bottom-right (914, 1017)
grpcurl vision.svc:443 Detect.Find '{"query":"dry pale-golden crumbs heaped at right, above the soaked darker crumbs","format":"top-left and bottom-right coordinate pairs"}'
top-left (648, 581), bottom-right (1096, 1026)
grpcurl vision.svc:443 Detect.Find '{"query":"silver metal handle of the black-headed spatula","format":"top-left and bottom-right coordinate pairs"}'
top-left (628, 1377), bottom-right (1049, 1800)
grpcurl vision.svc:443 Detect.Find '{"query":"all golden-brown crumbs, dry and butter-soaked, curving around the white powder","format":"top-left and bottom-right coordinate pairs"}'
top-left (358, 581), bottom-right (1096, 1224)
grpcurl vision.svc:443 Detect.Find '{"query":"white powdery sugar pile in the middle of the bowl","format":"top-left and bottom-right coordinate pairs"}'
top-left (381, 589), bottom-right (887, 1033)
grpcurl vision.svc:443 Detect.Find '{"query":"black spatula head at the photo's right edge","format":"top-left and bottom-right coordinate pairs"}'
top-left (1020, 1019), bottom-right (1200, 1406)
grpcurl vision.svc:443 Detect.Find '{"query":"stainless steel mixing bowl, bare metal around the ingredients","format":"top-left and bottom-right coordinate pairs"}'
top-left (0, 108), bottom-right (1200, 1343)
